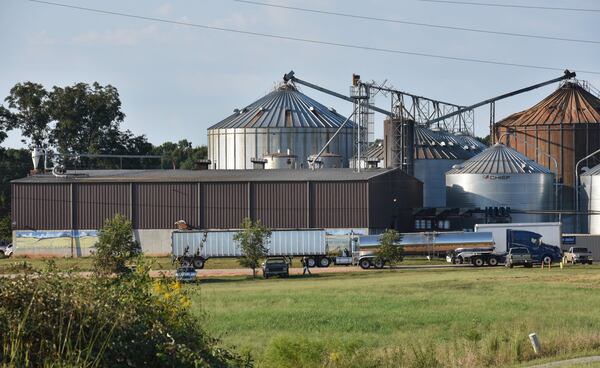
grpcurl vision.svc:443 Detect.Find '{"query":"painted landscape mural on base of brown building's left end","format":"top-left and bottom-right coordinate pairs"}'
top-left (14, 230), bottom-right (98, 250)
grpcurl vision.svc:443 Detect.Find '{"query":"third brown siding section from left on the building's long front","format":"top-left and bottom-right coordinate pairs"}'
top-left (133, 183), bottom-right (198, 229)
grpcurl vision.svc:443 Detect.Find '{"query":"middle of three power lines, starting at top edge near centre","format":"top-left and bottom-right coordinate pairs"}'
top-left (233, 0), bottom-right (600, 44)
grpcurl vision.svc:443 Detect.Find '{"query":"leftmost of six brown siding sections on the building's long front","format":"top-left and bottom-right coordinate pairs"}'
top-left (11, 183), bottom-right (71, 230)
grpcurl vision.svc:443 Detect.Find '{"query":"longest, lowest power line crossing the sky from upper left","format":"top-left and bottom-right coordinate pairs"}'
top-left (28, 0), bottom-right (600, 75)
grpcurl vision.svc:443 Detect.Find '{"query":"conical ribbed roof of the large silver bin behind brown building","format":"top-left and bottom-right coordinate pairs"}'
top-left (208, 84), bottom-right (354, 130)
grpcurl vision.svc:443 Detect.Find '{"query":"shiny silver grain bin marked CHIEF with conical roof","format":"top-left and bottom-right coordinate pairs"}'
top-left (446, 143), bottom-right (554, 222)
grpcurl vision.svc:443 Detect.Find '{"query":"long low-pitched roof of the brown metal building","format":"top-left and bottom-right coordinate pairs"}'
top-left (12, 168), bottom-right (404, 183)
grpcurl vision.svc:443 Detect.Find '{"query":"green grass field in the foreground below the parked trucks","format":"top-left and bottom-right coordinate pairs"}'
top-left (189, 266), bottom-right (600, 367)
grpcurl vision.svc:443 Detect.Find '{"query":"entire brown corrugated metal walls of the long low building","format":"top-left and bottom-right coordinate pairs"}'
top-left (12, 171), bottom-right (422, 230)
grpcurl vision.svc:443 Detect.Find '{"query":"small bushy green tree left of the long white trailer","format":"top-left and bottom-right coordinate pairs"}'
top-left (93, 213), bottom-right (140, 274)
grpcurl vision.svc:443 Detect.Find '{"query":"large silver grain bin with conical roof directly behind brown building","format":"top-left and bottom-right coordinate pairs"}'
top-left (208, 84), bottom-right (354, 169)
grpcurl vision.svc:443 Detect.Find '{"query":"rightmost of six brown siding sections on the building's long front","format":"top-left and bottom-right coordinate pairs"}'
top-left (310, 182), bottom-right (369, 228)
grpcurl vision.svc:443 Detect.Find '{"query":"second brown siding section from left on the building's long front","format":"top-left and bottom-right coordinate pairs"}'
top-left (73, 183), bottom-right (131, 230)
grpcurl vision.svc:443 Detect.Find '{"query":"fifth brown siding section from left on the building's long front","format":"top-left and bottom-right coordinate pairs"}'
top-left (250, 182), bottom-right (309, 228)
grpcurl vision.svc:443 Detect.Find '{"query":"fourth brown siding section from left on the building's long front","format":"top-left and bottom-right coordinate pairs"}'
top-left (200, 183), bottom-right (248, 229)
